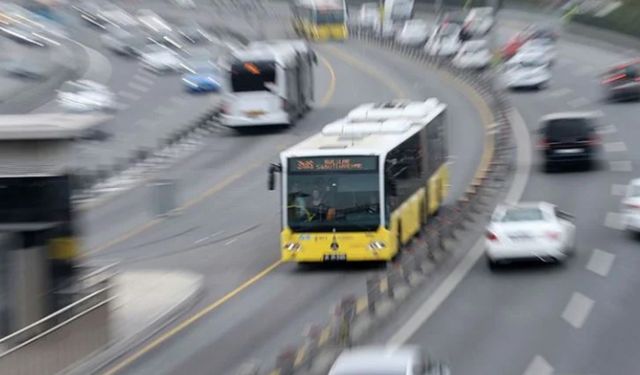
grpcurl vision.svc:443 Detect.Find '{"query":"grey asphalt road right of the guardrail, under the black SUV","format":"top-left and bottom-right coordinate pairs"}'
top-left (376, 8), bottom-right (640, 375)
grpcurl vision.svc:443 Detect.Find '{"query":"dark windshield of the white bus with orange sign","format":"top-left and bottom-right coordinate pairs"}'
top-left (231, 61), bottom-right (276, 92)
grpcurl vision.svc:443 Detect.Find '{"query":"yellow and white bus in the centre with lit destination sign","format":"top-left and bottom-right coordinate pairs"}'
top-left (269, 98), bottom-right (449, 262)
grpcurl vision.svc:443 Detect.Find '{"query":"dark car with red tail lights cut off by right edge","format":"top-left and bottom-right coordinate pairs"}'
top-left (601, 59), bottom-right (640, 100)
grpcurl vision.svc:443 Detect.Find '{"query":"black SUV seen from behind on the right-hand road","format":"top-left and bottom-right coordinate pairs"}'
top-left (538, 112), bottom-right (601, 172)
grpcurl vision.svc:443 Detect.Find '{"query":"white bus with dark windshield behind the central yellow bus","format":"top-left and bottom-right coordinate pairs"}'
top-left (220, 41), bottom-right (317, 128)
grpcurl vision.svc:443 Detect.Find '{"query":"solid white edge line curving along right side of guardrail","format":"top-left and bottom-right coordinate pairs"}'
top-left (387, 110), bottom-right (532, 346)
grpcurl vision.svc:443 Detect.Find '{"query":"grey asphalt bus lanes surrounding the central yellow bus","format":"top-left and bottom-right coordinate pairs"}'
top-left (81, 11), bottom-right (490, 374)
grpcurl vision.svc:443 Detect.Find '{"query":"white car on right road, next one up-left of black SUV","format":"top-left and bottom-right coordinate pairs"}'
top-left (502, 53), bottom-right (551, 89)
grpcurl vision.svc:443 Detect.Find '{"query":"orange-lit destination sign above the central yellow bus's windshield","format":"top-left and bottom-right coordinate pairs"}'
top-left (289, 156), bottom-right (378, 173)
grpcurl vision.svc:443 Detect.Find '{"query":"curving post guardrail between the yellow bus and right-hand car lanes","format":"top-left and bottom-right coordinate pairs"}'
top-left (248, 24), bottom-right (514, 375)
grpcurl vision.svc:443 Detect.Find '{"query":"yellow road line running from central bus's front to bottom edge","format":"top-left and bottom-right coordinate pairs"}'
top-left (103, 260), bottom-right (282, 375)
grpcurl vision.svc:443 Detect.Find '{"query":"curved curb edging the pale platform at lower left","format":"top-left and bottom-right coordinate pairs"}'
top-left (62, 276), bottom-right (204, 375)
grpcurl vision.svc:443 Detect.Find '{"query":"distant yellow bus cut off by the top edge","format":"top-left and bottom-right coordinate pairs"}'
top-left (291, 0), bottom-right (349, 41)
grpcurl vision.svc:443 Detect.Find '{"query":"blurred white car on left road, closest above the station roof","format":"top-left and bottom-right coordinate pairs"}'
top-left (58, 80), bottom-right (117, 112)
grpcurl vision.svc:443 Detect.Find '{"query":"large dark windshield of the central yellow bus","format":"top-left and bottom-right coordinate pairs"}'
top-left (287, 157), bottom-right (380, 232)
